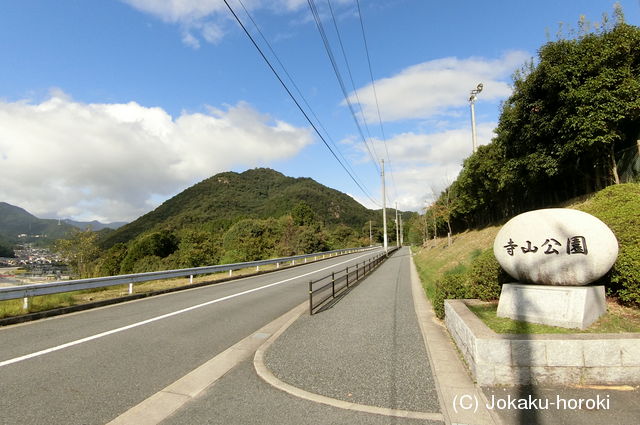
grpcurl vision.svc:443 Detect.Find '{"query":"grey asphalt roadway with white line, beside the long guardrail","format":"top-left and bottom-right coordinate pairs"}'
top-left (0, 251), bottom-right (379, 425)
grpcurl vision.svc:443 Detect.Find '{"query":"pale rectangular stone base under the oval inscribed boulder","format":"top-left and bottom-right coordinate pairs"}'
top-left (498, 283), bottom-right (607, 329)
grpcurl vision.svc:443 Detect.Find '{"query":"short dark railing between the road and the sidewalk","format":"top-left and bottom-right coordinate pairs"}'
top-left (309, 248), bottom-right (398, 315)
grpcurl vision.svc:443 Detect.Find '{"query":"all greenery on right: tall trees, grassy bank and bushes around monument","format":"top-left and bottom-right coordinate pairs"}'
top-left (409, 5), bottom-right (640, 332)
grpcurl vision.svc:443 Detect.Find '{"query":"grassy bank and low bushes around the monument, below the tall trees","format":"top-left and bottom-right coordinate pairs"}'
top-left (414, 183), bottom-right (640, 333)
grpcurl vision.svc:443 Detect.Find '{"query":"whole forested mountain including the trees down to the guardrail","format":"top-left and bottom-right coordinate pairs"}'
top-left (57, 168), bottom-right (415, 277)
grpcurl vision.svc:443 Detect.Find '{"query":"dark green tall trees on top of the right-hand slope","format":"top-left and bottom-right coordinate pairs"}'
top-left (424, 9), bottom-right (640, 231)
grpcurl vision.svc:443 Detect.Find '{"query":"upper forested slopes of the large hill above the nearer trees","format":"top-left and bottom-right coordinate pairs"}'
top-left (102, 168), bottom-right (380, 248)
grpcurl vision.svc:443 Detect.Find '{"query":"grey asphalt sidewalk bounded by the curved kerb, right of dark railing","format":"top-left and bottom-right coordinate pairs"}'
top-left (264, 248), bottom-right (444, 423)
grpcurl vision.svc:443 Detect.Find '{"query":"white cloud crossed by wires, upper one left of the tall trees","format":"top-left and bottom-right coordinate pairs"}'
top-left (350, 51), bottom-right (530, 122)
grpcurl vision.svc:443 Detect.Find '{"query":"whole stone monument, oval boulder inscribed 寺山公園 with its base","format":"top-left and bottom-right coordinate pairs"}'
top-left (493, 208), bottom-right (618, 329)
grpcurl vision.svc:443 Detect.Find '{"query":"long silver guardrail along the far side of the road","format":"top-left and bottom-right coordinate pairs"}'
top-left (0, 247), bottom-right (377, 306)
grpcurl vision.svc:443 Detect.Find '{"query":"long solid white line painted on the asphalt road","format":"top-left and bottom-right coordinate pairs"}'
top-left (0, 253), bottom-right (370, 367)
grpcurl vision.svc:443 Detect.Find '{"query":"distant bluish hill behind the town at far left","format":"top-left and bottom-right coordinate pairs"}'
top-left (0, 202), bottom-right (74, 243)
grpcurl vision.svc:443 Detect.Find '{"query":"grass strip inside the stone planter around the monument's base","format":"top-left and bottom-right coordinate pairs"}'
top-left (468, 300), bottom-right (640, 334)
